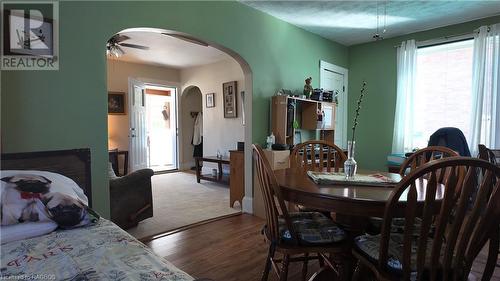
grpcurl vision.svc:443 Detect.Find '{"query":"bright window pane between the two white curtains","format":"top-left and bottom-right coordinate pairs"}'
top-left (413, 40), bottom-right (474, 148)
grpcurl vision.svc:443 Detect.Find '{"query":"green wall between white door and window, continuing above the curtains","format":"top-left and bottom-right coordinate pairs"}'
top-left (348, 16), bottom-right (500, 170)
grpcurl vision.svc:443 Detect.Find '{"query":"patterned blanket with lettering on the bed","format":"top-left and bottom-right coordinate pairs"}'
top-left (0, 219), bottom-right (193, 281)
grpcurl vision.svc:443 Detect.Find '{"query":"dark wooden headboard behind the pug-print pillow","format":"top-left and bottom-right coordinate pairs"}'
top-left (0, 148), bottom-right (92, 207)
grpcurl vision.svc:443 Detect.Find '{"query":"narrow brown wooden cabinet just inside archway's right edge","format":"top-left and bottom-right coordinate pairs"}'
top-left (229, 150), bottom-right (245, 207)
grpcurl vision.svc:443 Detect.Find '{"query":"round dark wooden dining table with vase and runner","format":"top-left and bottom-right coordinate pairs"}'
top-left (274, 168), bottom-right (444, 280)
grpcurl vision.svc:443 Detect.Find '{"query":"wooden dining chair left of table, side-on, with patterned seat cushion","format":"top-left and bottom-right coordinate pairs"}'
top-left (253, 145), bottom-right (348, 281)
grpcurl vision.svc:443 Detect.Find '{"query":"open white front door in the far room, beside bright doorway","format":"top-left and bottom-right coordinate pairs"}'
top-left (129, 79), bottom-right (148, 172)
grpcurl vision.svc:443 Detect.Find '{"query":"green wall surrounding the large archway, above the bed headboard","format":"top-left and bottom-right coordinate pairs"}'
top-left (1, 1), bottom-right (348, 216)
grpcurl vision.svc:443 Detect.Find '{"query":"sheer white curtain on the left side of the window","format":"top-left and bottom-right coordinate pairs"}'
top-left (392, 40), bottom-right (417, 153)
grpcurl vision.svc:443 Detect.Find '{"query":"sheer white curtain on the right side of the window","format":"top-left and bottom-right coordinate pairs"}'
top-left (469, 24), bottom-right (500, 155)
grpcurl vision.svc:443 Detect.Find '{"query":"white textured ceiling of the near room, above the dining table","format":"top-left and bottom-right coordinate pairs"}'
top-left (242, 0), bottom-right (500, 45)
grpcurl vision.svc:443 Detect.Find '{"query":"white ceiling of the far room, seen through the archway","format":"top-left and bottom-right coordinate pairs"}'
top-left (110, 29), bottom-right (231, 69)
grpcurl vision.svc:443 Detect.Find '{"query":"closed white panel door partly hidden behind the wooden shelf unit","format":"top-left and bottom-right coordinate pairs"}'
top-left (320, 61), bottom-right (348, 148)
